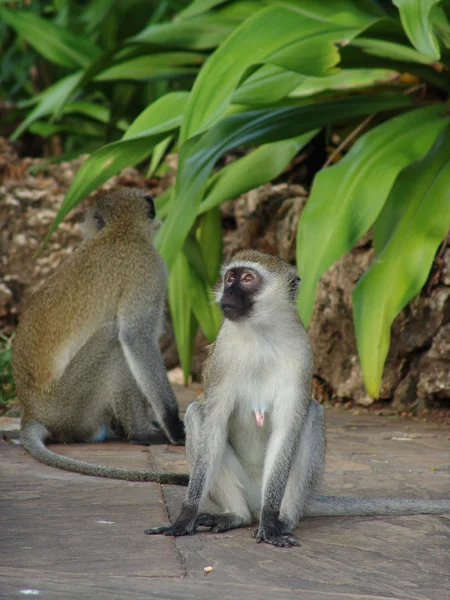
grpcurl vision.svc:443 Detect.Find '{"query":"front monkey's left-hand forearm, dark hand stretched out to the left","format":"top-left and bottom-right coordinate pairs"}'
top-left (145, 406), bottom-right (227, 536)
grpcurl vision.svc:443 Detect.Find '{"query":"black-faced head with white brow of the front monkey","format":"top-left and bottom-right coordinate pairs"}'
top-left (216, 250), bottom-right (300, 321)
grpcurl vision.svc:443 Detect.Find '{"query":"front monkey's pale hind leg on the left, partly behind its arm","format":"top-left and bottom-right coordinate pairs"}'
top-left (185, 402), bottom-right (252, 533)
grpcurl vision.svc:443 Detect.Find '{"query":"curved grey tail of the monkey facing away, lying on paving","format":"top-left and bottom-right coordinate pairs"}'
top-left (20, 421), bottom-right (189, 485)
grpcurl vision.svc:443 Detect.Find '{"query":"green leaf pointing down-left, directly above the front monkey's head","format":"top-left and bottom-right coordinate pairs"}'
top-left (198, 129), bottom-right (319, 214)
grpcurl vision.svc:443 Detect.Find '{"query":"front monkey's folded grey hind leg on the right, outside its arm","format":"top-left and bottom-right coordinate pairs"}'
top-left (280, 399), bottom-right (325, 533)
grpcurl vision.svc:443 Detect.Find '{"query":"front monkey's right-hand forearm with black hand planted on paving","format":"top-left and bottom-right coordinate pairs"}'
top-left (255, 399), bottom-right (304, 546)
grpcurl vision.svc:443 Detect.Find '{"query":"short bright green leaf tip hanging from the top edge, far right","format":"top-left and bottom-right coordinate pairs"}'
top-left (392, 0), bottom-right (441, 61)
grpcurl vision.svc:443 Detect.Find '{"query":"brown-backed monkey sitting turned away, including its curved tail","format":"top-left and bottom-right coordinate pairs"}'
top-left (13, 188), bottom-right (188, 485)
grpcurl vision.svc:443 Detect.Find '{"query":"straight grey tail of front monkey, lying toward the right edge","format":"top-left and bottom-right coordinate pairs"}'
top-left (306, 496), bottom-right (450, 517)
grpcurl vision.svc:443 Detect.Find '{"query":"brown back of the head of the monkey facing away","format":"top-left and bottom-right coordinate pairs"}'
top-left (83, 188), bottom-right (156, 237)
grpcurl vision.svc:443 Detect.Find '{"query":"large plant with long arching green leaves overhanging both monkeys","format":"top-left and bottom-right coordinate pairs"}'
top-left (9, 0), bottom-right (450, 397)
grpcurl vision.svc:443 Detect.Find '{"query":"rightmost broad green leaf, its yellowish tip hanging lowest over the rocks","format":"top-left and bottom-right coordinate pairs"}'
top-left (353, 128), bottom-right (450, 398)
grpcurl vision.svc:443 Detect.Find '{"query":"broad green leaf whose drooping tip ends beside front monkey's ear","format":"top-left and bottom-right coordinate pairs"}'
top-left (297, 105), bottom-right (450, 324)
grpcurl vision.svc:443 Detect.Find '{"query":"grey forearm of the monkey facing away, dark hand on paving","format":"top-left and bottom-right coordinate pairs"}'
top-left (119, 319), bottom-right (184, 444)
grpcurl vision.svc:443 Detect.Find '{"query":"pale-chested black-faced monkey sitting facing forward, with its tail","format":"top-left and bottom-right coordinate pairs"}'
top-left (146, 250), bottom-right (450, 547)
